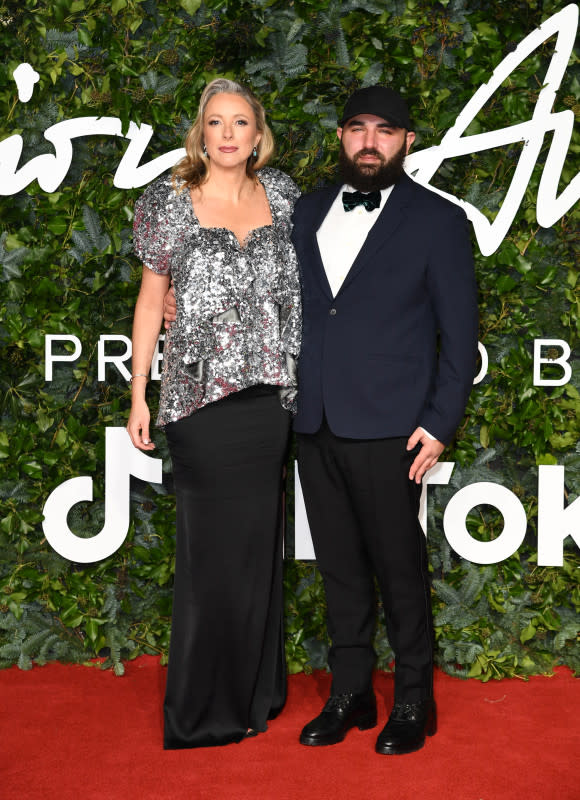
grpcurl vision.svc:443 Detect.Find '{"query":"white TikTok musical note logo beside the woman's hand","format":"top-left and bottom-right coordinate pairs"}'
top-left (42, 428), bottom-right (163, 564)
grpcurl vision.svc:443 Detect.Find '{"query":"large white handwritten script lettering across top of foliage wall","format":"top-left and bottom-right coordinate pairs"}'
top-left (0, 3), bottom-right (580, 256)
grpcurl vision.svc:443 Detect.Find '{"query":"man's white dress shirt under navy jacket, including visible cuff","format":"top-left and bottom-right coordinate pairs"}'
top-left (316, 184), bottom-right (435, 440)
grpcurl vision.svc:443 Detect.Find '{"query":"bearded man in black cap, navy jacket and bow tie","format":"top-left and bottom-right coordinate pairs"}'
top-left (293, 86), bottom-right (477, 754)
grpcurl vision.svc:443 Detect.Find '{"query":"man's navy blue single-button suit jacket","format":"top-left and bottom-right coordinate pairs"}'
top-left (293, 175), bottom-right (478, 444)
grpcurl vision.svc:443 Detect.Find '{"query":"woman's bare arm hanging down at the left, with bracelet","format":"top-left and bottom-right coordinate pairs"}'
top-left (127, 267), bottom-right (170, 450)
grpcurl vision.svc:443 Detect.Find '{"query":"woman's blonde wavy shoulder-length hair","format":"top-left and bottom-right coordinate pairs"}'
top-left (173, 78), bottom-right (274, 191)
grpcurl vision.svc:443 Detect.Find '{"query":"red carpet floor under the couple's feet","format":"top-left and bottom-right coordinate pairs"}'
top-left (0, 657), bottom-right (580, 800)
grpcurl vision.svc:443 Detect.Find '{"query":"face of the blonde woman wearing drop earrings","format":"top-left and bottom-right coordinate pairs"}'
top-left (203, 92), bottom-right (261, 168)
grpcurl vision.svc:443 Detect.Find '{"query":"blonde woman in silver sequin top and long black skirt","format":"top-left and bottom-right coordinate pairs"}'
top-left (127, 79), bottom-right (300, 749)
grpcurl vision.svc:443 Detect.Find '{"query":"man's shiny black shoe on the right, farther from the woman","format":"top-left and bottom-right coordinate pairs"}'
top-left (375, 698), bottom-right (437, 755)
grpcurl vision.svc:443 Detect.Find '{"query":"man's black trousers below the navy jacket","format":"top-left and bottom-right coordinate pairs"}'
top-left (298, 421), bottom-right (433, 703)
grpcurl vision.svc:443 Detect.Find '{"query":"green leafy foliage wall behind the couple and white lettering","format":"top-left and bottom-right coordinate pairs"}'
top-left (0, 0), bottom-right (580, 680)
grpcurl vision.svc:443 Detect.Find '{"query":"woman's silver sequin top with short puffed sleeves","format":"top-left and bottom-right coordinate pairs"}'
top-left (133, 168), bottom-right (301, 425)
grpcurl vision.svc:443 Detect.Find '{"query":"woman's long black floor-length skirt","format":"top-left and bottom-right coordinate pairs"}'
top-left (164, 386), bottom-right (290, 750)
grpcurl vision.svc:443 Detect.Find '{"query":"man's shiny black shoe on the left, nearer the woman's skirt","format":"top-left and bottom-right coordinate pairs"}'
top-left (300, 689), bottom-right (377, 747)
